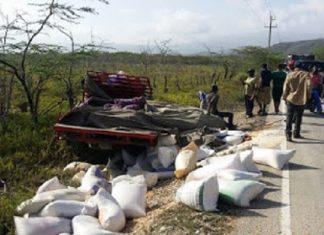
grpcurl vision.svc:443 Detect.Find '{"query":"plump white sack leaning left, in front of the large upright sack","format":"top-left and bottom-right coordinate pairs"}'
top-left (89, 188), bottom-right (126, 232)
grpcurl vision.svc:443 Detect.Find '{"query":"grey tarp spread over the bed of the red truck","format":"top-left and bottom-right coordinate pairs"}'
top-left (60, 103), bottom-right (226, 133)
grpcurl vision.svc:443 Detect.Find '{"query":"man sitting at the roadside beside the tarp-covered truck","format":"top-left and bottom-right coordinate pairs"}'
top-left (206, 85), bottom-right (235, 129)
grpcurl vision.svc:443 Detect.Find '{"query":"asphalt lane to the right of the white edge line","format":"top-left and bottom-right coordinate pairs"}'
top-left (288, 113), bottom-right (324, 234)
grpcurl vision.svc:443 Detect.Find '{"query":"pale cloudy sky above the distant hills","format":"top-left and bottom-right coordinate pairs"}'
top-left (0, 0), bottom-right (324, 53)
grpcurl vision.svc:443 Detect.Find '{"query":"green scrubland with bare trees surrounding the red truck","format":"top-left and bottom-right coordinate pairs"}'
top-left (0, 1), bottom-right (314, 234)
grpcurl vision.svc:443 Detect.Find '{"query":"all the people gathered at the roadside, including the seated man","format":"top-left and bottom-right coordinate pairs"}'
top-left (200, 61), bottom-right (323, 141)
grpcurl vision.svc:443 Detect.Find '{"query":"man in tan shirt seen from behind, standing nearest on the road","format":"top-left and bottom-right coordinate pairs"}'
top-left (283, 61), bottom-right (312, 141)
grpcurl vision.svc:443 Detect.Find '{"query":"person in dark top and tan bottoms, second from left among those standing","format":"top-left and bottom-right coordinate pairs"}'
top-left (257, 64), bottom-right (272, 116)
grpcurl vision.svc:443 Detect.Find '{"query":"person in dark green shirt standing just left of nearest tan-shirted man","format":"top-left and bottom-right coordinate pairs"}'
top-left (271, 64), bottom-right (287, 114)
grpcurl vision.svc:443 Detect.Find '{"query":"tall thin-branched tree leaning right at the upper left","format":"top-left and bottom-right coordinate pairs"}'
top-left (0, 0), bottom-right (108, 124)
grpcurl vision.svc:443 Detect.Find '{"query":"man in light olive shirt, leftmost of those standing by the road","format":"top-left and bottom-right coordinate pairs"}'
top-left (242, 69), bottom-right (257, 118)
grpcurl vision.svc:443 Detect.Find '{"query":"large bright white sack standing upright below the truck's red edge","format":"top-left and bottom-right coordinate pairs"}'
top-left (112, 175), bottom-right (147, 218)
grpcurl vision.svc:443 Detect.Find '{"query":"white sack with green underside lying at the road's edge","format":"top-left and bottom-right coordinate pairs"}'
top-left (218, 179), bottom-right (266, 207)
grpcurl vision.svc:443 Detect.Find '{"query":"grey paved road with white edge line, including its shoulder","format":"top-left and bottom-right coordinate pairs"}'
top-left (233, 107), bottom-right (324, 234)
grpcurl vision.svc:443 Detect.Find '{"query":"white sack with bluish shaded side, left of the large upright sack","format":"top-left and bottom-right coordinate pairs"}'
top-left (78, 166), bottom-right (110, 194)
